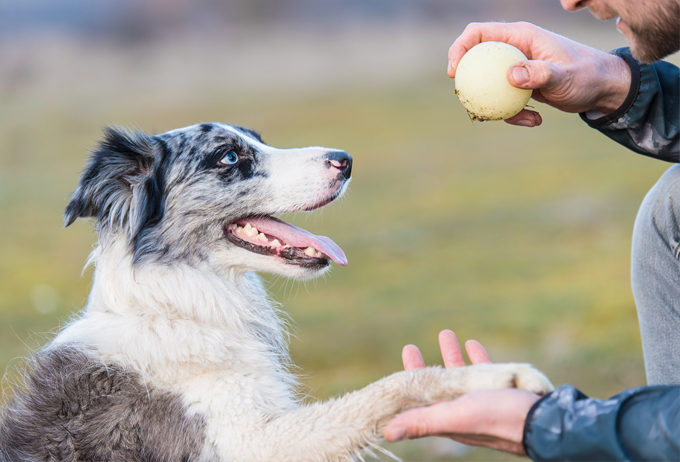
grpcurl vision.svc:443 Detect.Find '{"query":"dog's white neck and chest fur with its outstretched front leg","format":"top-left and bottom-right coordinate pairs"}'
top-left (55, 245), bottom-right (550, 462)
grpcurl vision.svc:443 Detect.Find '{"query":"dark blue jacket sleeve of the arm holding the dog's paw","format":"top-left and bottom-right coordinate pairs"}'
top-left (524, 385), bottom-right (680, 462)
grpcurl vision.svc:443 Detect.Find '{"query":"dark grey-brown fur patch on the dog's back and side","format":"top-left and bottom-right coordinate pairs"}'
top-left (0, 347), bottom-right (205, 462)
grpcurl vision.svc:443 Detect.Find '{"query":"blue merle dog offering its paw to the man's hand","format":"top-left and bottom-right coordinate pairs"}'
top-left (0, 123), bottom-right (552, 462)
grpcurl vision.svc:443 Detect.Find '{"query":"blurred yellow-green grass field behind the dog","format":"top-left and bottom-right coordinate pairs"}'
top-left (0, 42), bottom-right (668, 460)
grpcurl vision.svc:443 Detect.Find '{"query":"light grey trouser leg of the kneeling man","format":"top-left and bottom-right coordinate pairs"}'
top-left (631, 164), bottom-right (680, 385)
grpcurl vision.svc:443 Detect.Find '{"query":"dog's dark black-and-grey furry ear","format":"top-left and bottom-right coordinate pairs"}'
top-left (64, 127), bottom-right (162, 240)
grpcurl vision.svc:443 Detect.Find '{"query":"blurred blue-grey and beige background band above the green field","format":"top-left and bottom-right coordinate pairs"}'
top-left (0, 0), bottom-right (640, 123)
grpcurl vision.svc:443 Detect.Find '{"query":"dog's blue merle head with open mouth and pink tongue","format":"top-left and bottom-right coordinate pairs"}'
top-left (64, 123), bottom-right (352, 278)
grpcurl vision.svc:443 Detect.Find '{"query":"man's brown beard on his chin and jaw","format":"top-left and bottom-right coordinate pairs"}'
top-left (628, 13), bottom-right (680, 63)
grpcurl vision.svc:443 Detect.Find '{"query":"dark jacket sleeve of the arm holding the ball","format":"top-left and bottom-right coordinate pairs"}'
top-left (581, 48), bottom-right (680, 162)
